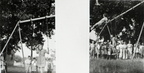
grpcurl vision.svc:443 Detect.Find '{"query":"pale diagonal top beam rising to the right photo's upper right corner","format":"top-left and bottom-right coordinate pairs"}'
top-left (92, 1), bottom-right (144, 35)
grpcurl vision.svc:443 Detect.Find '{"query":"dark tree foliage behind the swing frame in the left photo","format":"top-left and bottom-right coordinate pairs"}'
top-left (0, 0), bottom-right (55, 54)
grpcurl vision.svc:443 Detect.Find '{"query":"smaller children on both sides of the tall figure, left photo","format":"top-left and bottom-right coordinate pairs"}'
top-left (25, 56), bottom-right (53, 73)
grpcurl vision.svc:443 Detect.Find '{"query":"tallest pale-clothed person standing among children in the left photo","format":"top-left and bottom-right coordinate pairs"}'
top-left (37, 44), bottom-right (48, 73)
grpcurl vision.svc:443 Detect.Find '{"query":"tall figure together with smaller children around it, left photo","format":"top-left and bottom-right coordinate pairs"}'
top-left (25, 45), bottom-right (53, 73)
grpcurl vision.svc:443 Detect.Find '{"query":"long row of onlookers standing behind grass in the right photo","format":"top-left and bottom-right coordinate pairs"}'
top-left (90, 37), bottom-right (144, 59)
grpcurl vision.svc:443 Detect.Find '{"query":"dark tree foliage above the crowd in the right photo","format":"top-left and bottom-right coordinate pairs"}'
top-left (90, 0), bottom-right (144, 43)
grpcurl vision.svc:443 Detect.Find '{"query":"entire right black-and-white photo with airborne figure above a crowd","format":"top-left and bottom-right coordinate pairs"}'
top-left (89, 0), bottom-right (144, 73)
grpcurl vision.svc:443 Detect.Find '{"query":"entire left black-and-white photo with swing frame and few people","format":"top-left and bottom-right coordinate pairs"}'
top-left (0, 0), bottom-right (56, 73)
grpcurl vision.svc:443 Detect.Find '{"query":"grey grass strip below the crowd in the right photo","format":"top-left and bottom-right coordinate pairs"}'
top-left (90, 59), bottom-right (144, 73)
